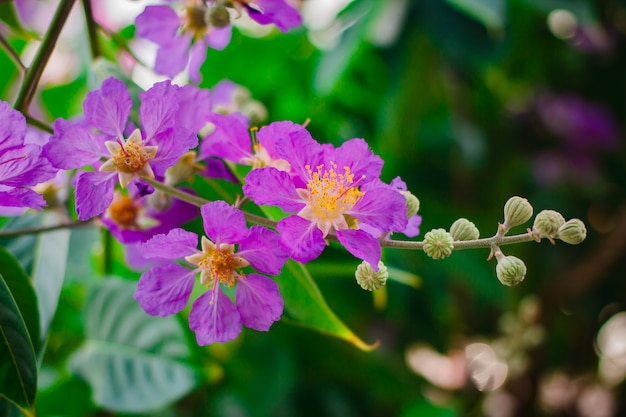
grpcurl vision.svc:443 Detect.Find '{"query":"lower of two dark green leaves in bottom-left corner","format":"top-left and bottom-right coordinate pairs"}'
top-left (0, 274), bottom-right (37, 410)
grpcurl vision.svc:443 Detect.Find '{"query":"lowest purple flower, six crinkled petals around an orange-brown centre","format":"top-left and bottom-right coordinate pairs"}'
top-left (135, 201), bottom-right (287, 345)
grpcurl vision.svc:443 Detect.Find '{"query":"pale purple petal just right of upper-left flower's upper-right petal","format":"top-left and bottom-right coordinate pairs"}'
top-left (176, 85), bottom-right (211, 134)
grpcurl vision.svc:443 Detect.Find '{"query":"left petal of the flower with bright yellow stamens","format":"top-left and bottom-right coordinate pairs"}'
top-left (243, 167), bottom-right (305, 212)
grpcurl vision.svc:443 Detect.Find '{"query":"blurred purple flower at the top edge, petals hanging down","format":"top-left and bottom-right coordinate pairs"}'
top-left (135, 0), bottom-right (232, 84)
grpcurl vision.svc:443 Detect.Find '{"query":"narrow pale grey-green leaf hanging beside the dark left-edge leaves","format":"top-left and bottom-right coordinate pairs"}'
top-left (32, 211), bottom-right (71, 340)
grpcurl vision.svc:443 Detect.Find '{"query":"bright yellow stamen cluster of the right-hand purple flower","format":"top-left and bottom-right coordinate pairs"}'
top-left (305, 162), bottom-right (365, 220)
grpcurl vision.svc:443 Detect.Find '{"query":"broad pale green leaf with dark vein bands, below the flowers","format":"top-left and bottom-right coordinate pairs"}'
top-left (70, 279), bottom-right (197, 413)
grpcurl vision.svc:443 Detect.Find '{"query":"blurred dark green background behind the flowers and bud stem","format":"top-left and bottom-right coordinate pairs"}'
top-left (0, 0), bottom-right (626, 417)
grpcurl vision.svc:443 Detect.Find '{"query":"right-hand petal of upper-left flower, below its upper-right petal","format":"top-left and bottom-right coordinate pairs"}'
top-left (149, 126), bottom-right (198, 177)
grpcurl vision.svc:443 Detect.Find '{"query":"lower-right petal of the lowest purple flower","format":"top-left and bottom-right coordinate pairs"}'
top-left (235, 274), bottom-right (284, 332)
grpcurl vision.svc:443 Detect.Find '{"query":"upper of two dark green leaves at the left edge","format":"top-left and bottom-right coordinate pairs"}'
top-left (0, 247), bottom-right (40, 352)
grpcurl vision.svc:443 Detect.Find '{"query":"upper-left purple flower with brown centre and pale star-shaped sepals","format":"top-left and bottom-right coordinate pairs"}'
top-left (44, 78), bottom-right (198, 220)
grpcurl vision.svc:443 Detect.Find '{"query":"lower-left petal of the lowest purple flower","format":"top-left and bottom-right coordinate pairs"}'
top-left (135, 264), bottom-right (196, 317)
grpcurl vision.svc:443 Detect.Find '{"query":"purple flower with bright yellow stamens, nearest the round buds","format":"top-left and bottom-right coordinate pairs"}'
top-left (243, 128), bottom-right (407, 265)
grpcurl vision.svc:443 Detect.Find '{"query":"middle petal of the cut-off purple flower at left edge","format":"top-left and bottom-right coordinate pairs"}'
top-left (0, 145), bottom-right (58, 187)
